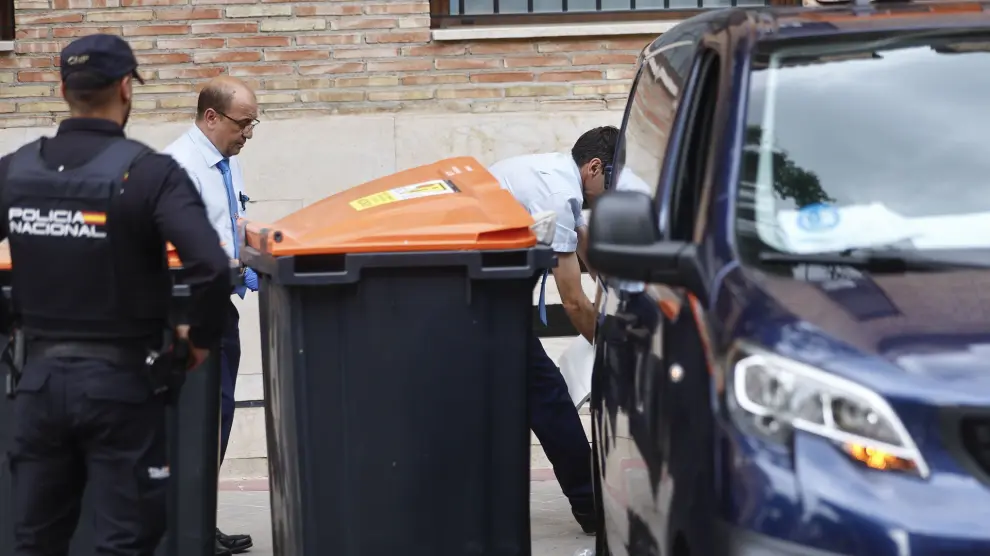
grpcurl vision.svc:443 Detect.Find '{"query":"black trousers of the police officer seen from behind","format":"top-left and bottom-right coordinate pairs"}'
top-left (10, 358), bottom-right (169, 556)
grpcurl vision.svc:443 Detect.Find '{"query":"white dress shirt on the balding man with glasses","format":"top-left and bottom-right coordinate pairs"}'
top-left (162, 124), bottom-right (244, 259)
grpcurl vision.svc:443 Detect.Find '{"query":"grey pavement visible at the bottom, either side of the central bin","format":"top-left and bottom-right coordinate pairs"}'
top-left (217, 470), bottom-right (595, 556)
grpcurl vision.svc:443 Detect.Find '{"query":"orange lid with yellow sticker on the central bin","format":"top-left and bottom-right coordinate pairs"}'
top-left (244, 157), bottom-right (536, 257)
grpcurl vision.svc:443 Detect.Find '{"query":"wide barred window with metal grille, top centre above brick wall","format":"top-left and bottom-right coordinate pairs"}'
top-left (430, 0), bottom-right (801, 28)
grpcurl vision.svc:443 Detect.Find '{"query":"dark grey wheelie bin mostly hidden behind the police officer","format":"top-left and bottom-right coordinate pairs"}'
top-left (0, 248), bottom-right (220, 556)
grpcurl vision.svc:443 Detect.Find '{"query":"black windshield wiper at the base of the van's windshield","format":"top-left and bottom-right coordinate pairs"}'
top-left (759, 249), bottom-right (990, 274)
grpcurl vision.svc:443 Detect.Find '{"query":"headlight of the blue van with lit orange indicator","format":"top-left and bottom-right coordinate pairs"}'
top-left (731, 353), bottom-right (929, 478)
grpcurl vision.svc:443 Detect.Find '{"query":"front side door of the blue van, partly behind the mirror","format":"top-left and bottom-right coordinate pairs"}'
top-left (649, 34), bottom-right (729, 556)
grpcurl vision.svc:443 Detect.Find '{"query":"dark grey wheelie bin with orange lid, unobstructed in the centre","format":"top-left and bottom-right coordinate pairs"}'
top-left (241, 158), bottom-right (555, 556)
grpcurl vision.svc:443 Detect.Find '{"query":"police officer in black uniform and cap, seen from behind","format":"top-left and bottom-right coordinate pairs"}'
top-left (0, 35), bottom-right (230, 556)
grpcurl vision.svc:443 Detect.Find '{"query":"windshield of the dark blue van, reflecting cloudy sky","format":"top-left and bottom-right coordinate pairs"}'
top-left (736, 32), bottom-right (990, 262)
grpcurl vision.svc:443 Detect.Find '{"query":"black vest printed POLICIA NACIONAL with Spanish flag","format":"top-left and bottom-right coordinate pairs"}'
top-left (0, 138), bottom-right (151, 339)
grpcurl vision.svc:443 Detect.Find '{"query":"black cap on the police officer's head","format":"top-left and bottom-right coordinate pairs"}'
top-left (62, 34), bottom-right (144, 90)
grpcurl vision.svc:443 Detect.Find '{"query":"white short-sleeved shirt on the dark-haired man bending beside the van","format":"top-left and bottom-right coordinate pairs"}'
top-left (488, 153), bottom-right (585, 253)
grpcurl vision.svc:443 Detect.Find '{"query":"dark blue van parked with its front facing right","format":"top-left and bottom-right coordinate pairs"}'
top-left (588, 2), bottom-right (990, 556)
